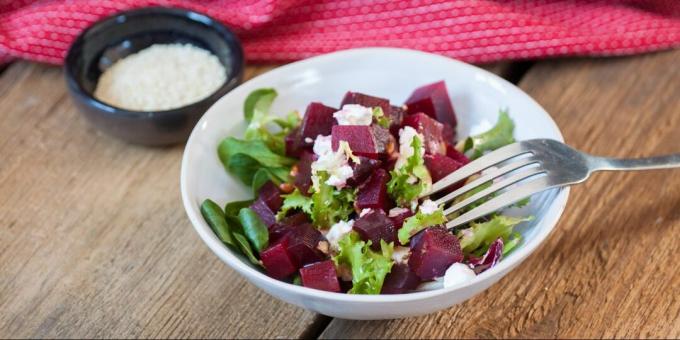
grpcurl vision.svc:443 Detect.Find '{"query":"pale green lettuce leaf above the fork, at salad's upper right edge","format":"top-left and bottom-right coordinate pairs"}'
top-left (464, 110), bottom-right (515, 160)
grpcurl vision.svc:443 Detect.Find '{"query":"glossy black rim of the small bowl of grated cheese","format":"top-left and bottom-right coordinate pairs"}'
top-left (63, 6), bottom-right (245, 118)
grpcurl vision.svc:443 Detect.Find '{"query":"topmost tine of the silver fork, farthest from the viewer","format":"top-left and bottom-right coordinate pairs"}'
top-left (419, 142), bottom-right (530, 198)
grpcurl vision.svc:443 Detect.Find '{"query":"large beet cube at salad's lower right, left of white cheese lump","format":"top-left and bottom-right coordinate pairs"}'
top-left (408, 227), bottom-right (463, 281)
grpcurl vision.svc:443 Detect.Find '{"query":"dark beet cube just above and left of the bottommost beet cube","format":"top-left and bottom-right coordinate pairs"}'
top-left (285, 223), bottom-right (326, 266)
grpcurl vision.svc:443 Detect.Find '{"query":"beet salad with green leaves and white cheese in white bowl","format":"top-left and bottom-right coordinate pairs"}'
top-left (201, 81), bottom-right (530, 294)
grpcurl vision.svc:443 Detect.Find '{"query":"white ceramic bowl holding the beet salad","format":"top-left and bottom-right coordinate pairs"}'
top-left (181, 48), bottom-right (569, 319)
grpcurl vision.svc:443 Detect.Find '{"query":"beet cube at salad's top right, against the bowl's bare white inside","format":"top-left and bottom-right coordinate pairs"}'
top-left (406, 81), bottom-right (456, 128)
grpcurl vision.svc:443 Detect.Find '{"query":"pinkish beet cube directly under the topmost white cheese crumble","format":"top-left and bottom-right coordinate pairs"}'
top-left (331, 125), bottom-right (380, 159)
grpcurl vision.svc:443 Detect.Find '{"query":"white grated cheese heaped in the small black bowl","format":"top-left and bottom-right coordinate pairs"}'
top-left (94, 44), bottom-right (227, 111)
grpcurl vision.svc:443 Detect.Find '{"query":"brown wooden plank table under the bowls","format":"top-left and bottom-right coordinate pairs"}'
top-left (0, 51), bottom-right (680, 338)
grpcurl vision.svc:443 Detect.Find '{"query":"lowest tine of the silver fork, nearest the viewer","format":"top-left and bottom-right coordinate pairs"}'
top-left (446, 176), bottom-right (558, 229)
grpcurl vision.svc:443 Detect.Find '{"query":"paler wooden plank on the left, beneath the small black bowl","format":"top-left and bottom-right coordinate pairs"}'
top-left (0, 62), bottom-right (325, 338)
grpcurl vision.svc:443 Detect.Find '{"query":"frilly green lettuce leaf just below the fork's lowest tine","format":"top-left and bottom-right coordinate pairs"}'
top-left (458, 215), bottom-right (533, 254)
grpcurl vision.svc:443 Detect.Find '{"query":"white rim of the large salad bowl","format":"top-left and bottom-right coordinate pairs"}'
top-left (180, 47), bottom-right (570, 303)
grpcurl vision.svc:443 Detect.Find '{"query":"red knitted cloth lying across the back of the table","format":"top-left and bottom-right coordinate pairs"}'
top-left (0, 0), bottom-right (680, 64)
